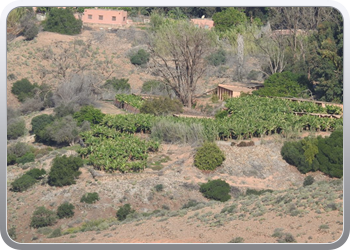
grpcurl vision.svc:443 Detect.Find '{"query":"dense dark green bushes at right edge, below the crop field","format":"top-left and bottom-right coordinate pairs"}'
top-left (281, 131), bottom-right (343, 178)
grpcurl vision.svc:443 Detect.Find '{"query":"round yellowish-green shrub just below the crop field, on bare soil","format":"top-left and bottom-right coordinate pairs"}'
top-left (194, 142), bottom-right (225, 170)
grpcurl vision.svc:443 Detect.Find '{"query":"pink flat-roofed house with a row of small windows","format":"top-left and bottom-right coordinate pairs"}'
top-left (81, 9), bottom-right (128, 25)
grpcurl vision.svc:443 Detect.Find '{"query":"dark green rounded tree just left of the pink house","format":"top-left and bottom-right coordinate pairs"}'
top-left (44, 8), bottom-right (82, 35)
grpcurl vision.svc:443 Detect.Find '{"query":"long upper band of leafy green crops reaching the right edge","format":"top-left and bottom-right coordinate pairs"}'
top-left (102, 95), bottom-right (343, 141)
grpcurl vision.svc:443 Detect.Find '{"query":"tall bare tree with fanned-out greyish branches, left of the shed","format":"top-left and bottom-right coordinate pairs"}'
top-left (149, 20), bottom-right (216, 107)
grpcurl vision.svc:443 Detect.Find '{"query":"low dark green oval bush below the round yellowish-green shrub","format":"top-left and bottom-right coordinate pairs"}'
top-left (199, 179), bottom-right (231, 202)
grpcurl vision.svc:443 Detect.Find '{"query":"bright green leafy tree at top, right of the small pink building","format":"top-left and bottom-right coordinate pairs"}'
top-left (212, 7), bottom-right (247, 32)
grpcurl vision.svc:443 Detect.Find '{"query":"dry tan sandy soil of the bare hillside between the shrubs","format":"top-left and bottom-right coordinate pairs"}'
top-left (7, 27), bottom-right (343, 243)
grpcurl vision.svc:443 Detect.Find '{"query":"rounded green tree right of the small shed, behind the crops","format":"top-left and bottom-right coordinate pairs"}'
top-left (253, 71), bottom-right (311, 97)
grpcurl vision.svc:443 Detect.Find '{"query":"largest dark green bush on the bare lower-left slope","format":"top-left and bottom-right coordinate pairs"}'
top-left (48, 155), bottom-right (83, 187)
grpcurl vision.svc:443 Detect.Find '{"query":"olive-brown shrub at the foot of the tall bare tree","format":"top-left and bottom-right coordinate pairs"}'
top-left (140, 97), bottom-right (183, 116)
